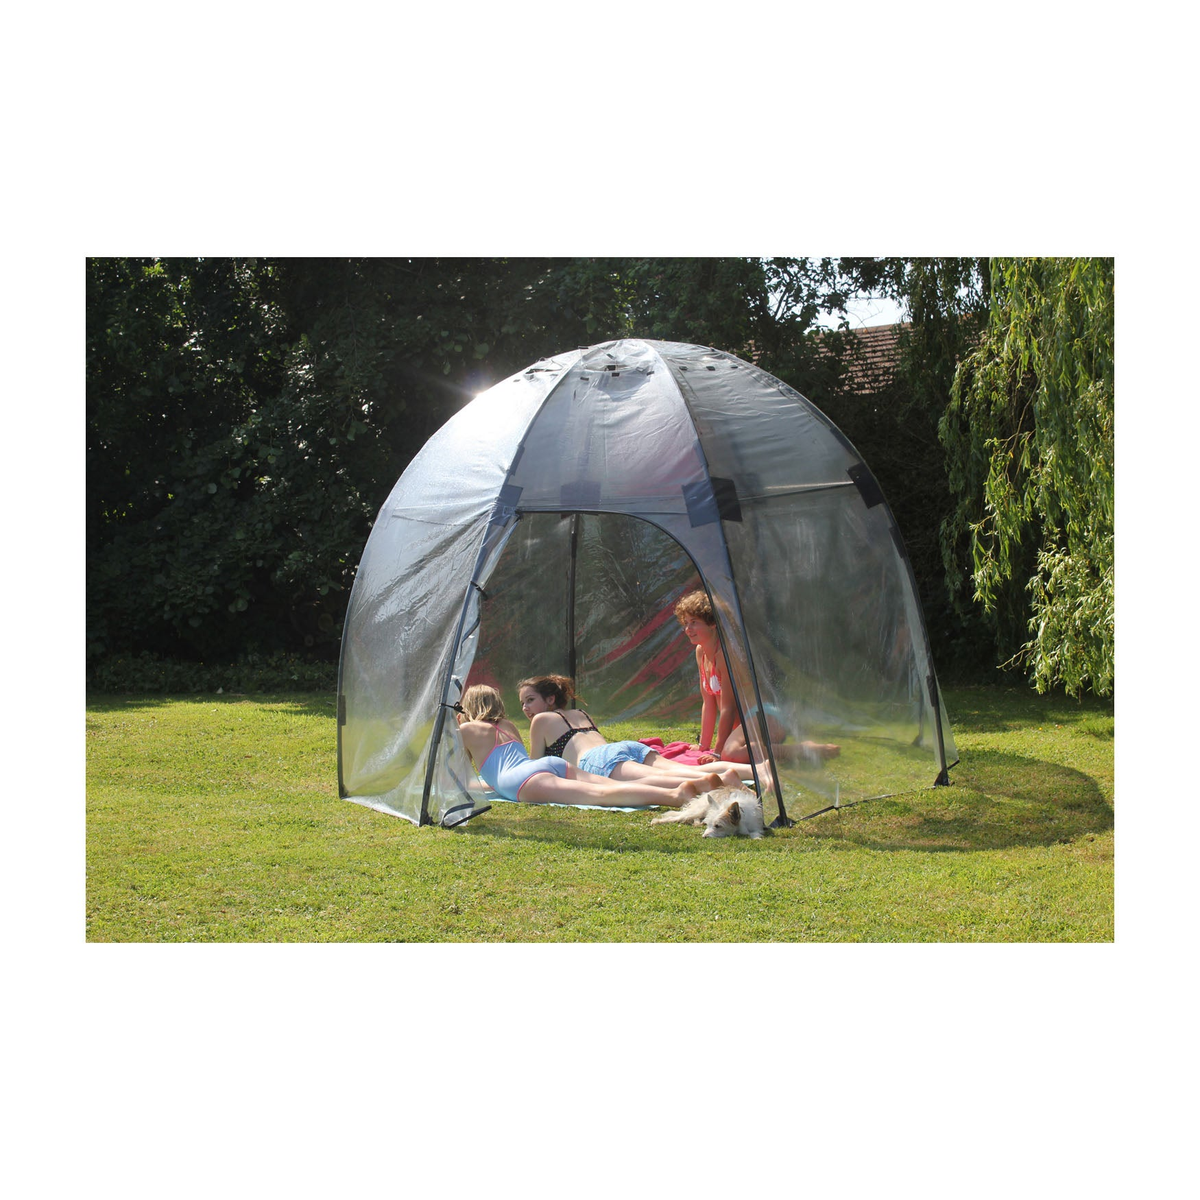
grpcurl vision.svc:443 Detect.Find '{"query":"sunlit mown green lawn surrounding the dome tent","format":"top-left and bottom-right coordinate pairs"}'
top-left (86, 688), bottom-right (1114, 942)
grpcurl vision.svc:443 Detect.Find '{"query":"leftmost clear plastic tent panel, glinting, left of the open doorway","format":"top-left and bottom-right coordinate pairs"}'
top-left (338, 343), bottom-right (578, 821)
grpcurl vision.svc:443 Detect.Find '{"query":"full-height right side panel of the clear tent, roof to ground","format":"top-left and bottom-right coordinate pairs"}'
top-left (664, 348), bottom-right (948, 811)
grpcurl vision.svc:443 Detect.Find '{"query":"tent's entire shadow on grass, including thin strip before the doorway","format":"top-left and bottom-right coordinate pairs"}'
top-left (460, 751), bottom-right (1112, 854)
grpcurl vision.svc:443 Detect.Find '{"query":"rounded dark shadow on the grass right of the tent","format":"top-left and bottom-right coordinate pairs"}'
top-left (805, 750), bottom-right (1112, 852)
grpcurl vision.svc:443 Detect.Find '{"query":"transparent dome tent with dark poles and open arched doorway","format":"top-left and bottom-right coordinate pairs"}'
top-left (337, 340), bottom-right (956, 827)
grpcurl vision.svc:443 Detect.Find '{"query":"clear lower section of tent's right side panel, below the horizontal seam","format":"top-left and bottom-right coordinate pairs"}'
top-left (731, 488), bottom-right (940, 803)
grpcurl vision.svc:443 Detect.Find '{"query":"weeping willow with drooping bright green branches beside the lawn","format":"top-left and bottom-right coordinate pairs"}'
top-left (940, 258), bottom-right (1114, 695)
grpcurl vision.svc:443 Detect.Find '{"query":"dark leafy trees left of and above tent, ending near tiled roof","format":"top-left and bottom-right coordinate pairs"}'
top-left (86, 258), bottom-right (873, 673)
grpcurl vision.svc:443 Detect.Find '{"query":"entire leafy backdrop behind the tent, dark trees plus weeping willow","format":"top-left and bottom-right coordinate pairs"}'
top-left (86, 258), bottom-right (1111, 700)
